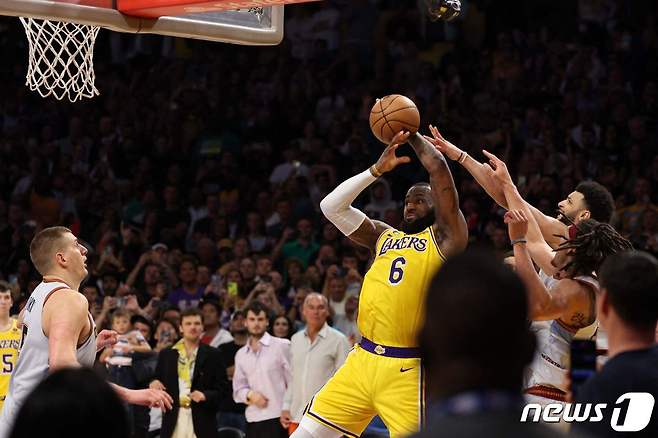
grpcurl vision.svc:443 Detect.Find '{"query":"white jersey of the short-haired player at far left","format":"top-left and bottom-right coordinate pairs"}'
top-left (0, 282), bottom-right (96, 438)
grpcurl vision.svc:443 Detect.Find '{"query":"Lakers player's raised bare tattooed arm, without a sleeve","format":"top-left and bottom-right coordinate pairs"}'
top-left (409, 134), bottom-right (468, 256)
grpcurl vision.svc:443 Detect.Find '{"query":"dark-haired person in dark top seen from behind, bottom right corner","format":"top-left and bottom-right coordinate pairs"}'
top-left (573, 251), bottom-right (658, 437)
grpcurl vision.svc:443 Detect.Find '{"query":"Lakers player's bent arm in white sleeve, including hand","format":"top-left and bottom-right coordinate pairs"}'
top-left (320, 131), bottom-right (410, 251)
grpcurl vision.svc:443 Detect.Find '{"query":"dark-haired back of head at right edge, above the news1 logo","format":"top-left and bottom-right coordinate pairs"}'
top-left (599, 251), bottom-right (658, 333)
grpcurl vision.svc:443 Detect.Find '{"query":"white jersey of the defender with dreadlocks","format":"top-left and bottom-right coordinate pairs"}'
top-left (524, 270), bottom-right (599, 392)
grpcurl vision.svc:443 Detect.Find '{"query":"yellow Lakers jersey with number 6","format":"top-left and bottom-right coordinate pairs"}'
top-left (357, 226), bottom-right (445, 348)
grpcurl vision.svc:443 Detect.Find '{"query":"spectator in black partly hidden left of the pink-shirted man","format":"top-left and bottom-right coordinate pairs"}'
top-left (218, 310), bottom-right (249, 432)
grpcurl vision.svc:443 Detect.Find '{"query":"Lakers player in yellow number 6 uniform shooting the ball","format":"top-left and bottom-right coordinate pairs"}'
top-left (292, 132), bottom-right (468, 438)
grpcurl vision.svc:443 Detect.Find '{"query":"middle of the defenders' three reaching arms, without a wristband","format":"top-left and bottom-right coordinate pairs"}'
top-left (483, 151), bottom-right (556, 275)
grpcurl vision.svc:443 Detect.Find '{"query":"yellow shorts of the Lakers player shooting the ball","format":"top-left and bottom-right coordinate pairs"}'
top-left (304, 345), bottom-right (425, 437)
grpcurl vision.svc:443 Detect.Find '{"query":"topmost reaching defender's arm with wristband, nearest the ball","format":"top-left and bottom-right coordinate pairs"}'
top-left (425, 125), bottom-right (566, 248)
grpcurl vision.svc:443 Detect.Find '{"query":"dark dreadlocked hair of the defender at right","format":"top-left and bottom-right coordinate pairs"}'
top-left (556, 219), bottom-right (633, 276)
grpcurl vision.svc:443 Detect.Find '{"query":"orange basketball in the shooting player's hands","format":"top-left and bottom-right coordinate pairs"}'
top-left (370, 94), bottom-right (420, 144)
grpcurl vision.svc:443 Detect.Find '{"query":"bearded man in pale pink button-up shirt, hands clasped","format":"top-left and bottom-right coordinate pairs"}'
top-left (233, 301), bottom-right (291, 438)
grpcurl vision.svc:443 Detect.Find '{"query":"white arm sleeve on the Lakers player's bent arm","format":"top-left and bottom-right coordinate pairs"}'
top-left (320, 169), bottom-right (377, 236)
